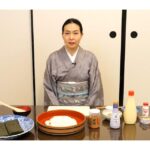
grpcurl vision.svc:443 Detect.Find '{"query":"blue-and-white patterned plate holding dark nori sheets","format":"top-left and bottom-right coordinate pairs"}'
top-left (0, 115), bottom-right (34, 139)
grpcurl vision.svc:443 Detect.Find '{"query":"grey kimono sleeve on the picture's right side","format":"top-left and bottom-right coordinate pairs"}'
top-left (88, 55), bottom-right (104, 107)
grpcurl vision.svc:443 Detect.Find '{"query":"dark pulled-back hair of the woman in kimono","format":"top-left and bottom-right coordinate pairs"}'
top-left (62, 18), bottom-right (83, 34)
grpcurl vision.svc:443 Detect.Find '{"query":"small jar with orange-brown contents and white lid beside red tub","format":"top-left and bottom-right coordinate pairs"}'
top-left (88, 108), bottom-right (100, 128)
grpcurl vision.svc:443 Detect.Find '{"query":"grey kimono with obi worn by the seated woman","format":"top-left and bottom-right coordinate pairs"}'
top-left (44, 47), bottom-right (104, 107)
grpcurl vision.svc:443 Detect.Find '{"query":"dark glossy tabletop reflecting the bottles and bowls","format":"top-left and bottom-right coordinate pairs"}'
top-left (0, 106), bottom-right (150, 140)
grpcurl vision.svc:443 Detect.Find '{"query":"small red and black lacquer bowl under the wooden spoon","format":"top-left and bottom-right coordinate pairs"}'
top-left (13, 106), bottom-right (31, 116)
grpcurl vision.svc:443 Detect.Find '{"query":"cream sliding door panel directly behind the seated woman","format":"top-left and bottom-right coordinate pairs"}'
top-left (34, 10), bottom-right (121, 104)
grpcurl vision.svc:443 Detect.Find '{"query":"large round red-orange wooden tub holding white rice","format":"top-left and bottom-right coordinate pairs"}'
top-left (37, 109), bottom-right (86, 135)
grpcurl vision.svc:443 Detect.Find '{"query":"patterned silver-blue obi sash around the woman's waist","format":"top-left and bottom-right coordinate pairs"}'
top-left (57, 81), bottom-right (89, 106)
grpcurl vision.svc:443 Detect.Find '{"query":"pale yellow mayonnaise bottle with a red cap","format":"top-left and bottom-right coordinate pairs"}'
top-left (124, 90), bottom-right (137, 124)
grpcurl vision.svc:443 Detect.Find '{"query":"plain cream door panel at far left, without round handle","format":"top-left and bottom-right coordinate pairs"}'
top-left (0, 10), bottom-right (33, 105)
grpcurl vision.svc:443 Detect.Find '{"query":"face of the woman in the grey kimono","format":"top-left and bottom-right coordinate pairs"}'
top-left (62, 23), bottom-right (82, 51)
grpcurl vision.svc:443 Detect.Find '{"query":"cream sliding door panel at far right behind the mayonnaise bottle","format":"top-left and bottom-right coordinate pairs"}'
top-left (124, 10), bottom-right (150, 105)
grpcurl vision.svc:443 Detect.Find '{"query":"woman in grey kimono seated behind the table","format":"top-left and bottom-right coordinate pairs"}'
top-left (44, 18), bottom-right (104, 107)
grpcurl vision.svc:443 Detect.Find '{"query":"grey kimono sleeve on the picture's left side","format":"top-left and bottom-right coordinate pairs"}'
top-left (43, 58), bottom-right (59, 106)
